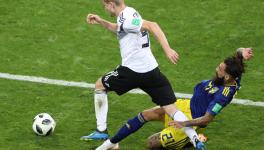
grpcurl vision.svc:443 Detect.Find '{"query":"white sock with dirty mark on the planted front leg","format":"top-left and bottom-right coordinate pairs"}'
top-left (94, 90), bottom-right (108, 131)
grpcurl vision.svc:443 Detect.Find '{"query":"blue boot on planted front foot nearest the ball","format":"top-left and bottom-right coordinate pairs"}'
top-left (80, 130), bottom-right (109, 141)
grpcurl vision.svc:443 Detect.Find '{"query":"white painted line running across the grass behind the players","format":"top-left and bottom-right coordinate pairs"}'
top-left (0, 73), bottom-right (264, 107)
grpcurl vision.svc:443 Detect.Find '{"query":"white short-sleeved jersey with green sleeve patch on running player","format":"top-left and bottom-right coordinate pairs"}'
top-left (117, 7), bottom-right (158, 73)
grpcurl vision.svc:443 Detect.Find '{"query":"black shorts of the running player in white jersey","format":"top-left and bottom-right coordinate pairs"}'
top-left (102, 66), bottom-right (176, 106)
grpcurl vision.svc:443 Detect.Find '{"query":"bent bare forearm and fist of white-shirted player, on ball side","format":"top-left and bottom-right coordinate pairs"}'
top-left (86, 14), bottom-right (117, 32)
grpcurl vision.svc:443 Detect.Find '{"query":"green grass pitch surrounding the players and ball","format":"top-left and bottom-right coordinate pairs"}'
top-left (0, 0), bottom-right (264, 150)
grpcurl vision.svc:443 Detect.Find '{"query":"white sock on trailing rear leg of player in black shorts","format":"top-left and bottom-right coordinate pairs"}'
top-left (173, 110), bottom-right (198, 147)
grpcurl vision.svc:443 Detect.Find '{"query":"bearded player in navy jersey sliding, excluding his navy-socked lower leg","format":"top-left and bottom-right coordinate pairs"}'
top-left (143, 48), bottom-right (253, 150)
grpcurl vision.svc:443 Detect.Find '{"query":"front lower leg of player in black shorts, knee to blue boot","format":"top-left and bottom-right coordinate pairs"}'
top-left (81, 78), bottom-right (109, 140)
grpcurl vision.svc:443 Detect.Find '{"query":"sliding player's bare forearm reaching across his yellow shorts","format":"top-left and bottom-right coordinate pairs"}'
top-left (169, 112), bottom-right (214, 128)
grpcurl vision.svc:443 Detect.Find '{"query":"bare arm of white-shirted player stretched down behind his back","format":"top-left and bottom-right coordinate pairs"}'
top-left (141, 20), bottom-right (179, 64)
